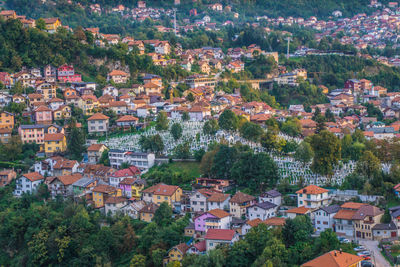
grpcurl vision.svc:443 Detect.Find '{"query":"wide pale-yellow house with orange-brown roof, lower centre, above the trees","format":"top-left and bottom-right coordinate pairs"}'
top-left (142, 183), bottom-right (182, 207)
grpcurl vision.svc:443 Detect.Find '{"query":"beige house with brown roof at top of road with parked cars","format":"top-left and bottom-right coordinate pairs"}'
top-left (352, 205), bottom-right (384, 239)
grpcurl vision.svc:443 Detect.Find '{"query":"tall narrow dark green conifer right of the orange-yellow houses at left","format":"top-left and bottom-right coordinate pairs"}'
top-left (67, 118), bottom-right (86, 160)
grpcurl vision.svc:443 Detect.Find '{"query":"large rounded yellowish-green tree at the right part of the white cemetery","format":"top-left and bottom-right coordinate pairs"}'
top-left (311, 130), bottom-right (341, 175)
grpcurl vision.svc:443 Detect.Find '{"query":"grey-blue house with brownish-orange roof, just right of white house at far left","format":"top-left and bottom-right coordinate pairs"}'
top-left (48, 173), bottom-right (82, 198)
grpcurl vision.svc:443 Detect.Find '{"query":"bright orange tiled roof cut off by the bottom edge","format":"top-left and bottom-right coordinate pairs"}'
top-left (301, 250), bottom-right (364, 267)
